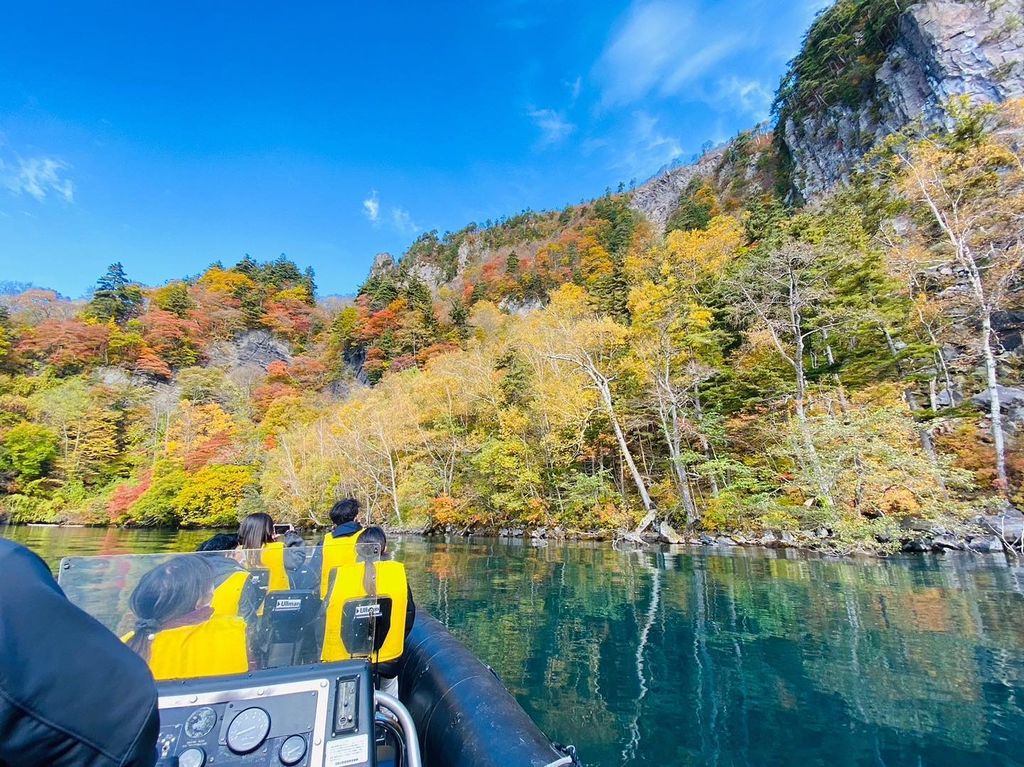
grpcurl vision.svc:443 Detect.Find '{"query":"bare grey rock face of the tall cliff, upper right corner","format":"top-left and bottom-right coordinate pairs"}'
top-left (780, 0), bottom-right (1024, 199)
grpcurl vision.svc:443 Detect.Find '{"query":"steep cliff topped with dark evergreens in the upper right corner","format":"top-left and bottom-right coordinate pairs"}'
top-left (776, 0), bottom-right (1024, 199)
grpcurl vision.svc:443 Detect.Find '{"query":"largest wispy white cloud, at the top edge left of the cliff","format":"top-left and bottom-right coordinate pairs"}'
top-left (596, 0), bottom-right (744, 106)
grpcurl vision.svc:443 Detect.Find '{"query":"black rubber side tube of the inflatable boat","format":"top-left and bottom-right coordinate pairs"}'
top-left (398, 611), bottom-right (573, 767)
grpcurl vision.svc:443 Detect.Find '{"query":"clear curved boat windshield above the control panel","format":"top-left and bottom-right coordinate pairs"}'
top-left (58, 544), bottom-right (391, 680)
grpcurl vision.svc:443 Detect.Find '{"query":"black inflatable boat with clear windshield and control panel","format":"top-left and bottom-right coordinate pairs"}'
top-left (58, 552), bottom-right (580, 767)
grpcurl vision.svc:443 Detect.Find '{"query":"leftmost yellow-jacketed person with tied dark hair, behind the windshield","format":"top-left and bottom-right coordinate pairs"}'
top-left (124, 554), bottom-right (249, 679)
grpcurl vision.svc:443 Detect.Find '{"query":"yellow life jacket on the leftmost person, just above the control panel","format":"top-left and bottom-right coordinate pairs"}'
top-left (122, 614), bottom-right (249, 681)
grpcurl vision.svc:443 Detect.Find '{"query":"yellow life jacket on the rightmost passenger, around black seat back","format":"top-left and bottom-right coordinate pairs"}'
top-left (321, 561), bottom-right (409, 663)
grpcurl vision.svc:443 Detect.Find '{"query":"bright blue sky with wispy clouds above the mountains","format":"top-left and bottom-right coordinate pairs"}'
top-left (0, 0), bottom-right (822, 296)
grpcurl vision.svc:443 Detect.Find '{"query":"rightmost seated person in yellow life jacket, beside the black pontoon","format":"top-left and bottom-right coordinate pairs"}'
top-left (321, 527), bottom-right (416, 696)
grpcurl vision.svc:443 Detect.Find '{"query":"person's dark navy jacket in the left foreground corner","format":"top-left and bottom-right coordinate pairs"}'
top-left (0, 541), bottom-right (160, 767)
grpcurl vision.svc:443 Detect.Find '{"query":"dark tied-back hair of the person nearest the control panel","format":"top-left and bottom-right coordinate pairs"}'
top-left (128, 554), bottom-right (213, 659)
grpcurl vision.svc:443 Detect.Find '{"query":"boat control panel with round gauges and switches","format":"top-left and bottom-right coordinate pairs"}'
top-left (157, 661), bottom-right (375, 767)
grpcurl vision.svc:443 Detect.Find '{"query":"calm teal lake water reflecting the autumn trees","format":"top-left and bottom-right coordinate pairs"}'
top-left (0, 527), bottom-right (1024, 767)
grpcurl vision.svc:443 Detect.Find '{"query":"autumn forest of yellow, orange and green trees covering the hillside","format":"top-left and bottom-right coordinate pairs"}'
top-left (0, 102), bottom-right (1024, 551)
